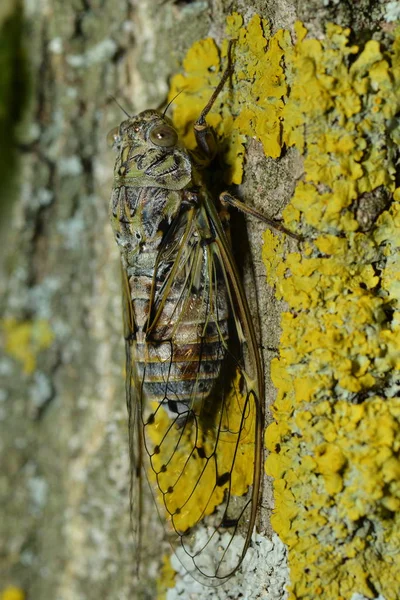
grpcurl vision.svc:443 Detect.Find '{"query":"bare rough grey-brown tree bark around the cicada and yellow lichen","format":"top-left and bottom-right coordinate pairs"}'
top-left (0, 0), bottom-right (392, 600)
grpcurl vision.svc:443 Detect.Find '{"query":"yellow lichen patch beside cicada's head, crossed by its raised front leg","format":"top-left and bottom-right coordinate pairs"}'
top-left (169, 13), bottom-right (291, 183)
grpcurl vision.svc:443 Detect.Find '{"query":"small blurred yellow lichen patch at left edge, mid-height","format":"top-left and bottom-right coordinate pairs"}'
top-left (1, 319), bottom-right (54, 375)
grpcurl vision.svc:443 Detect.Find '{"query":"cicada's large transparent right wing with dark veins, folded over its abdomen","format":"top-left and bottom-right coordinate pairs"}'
top-left (127, 203), bottom-right (264, 584)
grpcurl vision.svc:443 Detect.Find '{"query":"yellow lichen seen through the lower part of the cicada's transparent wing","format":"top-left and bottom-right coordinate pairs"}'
top-left (145, 378), bottom-right (255, 533)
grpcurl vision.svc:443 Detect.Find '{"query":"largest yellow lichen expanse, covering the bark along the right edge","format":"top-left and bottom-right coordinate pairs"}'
top-left (264, 19), bottom-right (400, 600)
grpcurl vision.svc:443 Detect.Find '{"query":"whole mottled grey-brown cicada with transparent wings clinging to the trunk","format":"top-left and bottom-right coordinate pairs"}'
top-left (110, 52), bottom-right (292, 585)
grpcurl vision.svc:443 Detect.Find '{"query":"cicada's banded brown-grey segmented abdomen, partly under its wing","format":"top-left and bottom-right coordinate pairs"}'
top-left (130, 276), bottom-right (228, 415)
